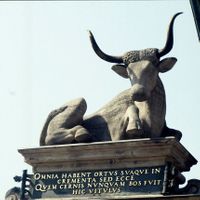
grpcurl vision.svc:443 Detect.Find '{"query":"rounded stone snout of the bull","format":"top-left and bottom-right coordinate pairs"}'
top-left (130, 84), bottom-right (149, 102)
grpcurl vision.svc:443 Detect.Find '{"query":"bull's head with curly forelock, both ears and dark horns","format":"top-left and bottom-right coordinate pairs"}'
top-left (89, 12), bottom-right (181, 101)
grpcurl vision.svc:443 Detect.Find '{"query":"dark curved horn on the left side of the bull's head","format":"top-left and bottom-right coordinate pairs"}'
top-left (88, 31), bottom-right (123, 63)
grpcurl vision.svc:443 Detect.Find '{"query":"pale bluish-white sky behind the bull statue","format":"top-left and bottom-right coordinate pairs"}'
top-left (0, 0), bottom-right (200, 199)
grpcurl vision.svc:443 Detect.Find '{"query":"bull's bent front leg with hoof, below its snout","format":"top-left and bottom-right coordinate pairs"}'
top-left (124, 104), bottom-right (144, 139)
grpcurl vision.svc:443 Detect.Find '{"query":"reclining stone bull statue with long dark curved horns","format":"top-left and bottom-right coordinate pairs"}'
top-left (40, 13), bottom-right (182, 145)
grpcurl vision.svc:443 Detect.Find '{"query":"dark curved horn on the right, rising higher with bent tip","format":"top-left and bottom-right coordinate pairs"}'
top-left (158, 12), bottom-right (182, 57)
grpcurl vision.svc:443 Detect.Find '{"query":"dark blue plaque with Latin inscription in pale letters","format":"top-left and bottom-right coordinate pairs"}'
top-left (32, 166), bottom-right (165, 198)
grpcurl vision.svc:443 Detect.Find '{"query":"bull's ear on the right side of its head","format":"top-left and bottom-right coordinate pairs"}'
top-left (158, 57), bottom-right (177, 73)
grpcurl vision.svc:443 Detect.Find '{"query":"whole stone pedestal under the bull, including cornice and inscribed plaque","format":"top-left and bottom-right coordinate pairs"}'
top-left (19, 137), bottom-right (200, 200)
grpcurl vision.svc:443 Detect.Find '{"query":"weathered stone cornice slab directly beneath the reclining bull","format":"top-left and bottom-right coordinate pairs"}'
top-left (19, 137), bottom-right (197, 172)
